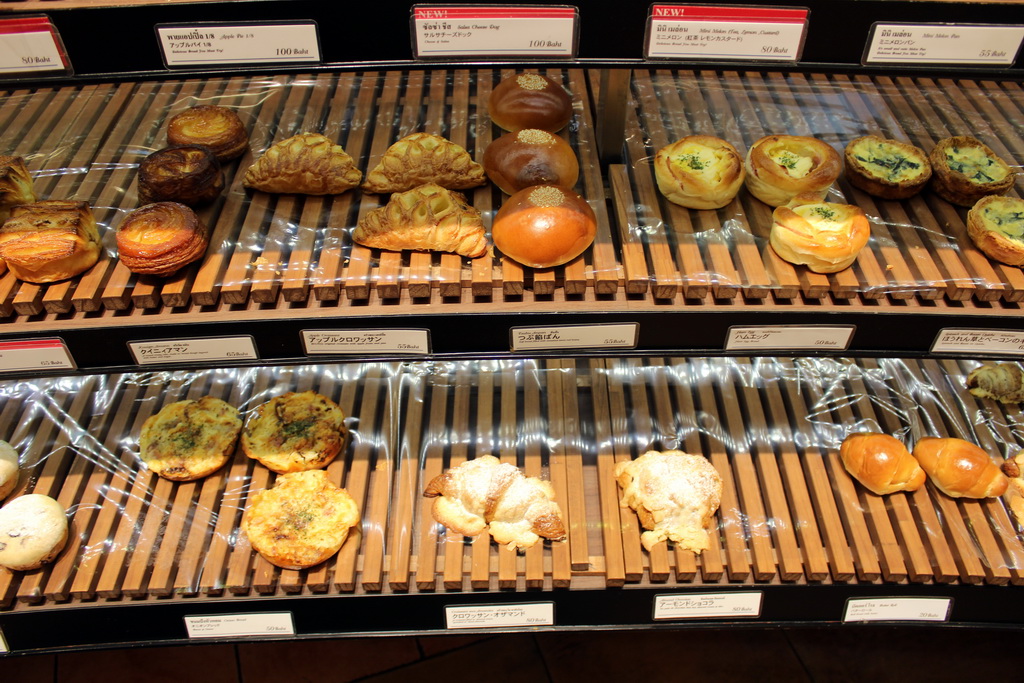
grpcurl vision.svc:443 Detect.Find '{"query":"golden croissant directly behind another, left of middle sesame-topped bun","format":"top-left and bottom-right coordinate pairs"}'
top-left (362, 133), bottom-right (486, 193)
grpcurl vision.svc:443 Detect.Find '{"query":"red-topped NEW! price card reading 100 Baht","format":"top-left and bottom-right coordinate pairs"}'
top-left (413, 5), bottom-right (580, 59)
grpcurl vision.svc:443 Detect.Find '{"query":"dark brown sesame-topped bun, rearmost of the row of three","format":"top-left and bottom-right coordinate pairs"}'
top-left (487, 74), bottom-right (572, 133)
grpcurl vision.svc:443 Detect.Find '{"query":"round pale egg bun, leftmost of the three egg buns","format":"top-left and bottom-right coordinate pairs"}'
top-left (654, 135), bottom-right (746, 209)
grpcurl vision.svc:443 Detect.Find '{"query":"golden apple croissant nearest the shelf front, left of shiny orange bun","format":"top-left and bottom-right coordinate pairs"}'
top-left (352, 183), bottom-right (489, 258)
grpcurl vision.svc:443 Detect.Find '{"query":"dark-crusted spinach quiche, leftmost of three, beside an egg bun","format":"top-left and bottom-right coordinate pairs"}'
top-left (843, 135), bottom-right (932, 200)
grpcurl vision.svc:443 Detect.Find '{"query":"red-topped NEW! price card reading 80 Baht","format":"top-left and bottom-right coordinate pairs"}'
top-left (644, 4), bottom-right (810, 61)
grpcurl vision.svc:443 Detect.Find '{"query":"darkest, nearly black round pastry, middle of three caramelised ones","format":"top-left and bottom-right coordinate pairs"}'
top-left (138, 144), bottom-right (224, 206)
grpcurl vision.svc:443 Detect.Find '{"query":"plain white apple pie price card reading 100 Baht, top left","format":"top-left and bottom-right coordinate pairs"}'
top-left (157, 22), bottom-right (321, 67)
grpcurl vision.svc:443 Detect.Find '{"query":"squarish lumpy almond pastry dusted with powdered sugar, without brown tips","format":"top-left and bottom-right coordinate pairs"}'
top-left (615, 451), bottom-right (722, 553)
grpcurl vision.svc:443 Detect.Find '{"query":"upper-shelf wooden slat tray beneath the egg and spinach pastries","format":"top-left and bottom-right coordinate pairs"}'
top-left (609, 70), bottom-right (1024, 301)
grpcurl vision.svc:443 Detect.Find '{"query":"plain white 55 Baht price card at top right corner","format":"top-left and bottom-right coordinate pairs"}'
top-left (863, 24), bottom-right (1024, 67)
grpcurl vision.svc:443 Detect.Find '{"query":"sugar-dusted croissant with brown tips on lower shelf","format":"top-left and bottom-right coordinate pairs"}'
top-left (423, 456), bottom-right (565, 550)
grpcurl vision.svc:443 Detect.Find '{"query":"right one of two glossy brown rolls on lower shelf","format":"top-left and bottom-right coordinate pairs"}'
top-left (913, 436), bottom-right (1009, 498)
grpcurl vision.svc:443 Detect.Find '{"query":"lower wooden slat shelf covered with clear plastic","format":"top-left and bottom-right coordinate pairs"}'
top-left (0, 357), bottom-right (1024, 651)
